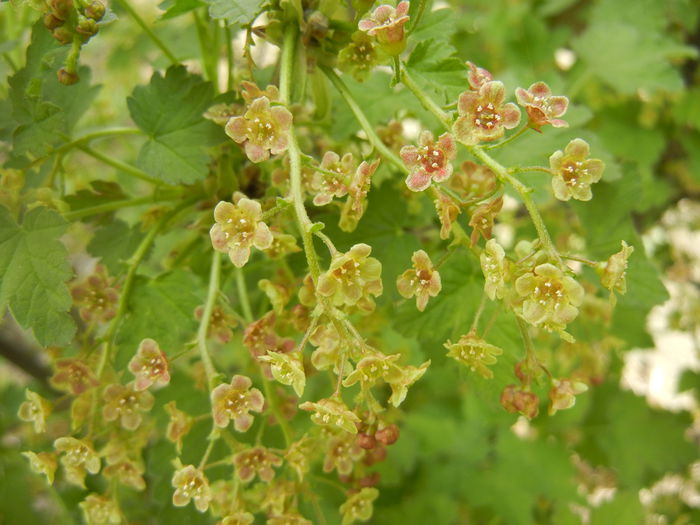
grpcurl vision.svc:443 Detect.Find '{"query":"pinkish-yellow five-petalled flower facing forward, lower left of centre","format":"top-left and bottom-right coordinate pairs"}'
top-left (211, 375), bottom-right (265, 432)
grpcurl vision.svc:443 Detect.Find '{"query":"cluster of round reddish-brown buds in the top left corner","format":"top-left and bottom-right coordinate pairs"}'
top-left (41, 0), bottom-right (106, 85)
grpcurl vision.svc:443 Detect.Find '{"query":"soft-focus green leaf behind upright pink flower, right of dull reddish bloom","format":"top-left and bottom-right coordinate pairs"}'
top-left (117, 270), bottom-right (205, 366)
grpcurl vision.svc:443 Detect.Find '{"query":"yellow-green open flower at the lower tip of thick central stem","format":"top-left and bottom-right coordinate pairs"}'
top-left (317, 243), bottom-right (383, 312)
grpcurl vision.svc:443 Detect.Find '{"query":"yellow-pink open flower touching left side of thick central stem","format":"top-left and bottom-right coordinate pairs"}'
top-left (226, 97), bottom-right (292, 163)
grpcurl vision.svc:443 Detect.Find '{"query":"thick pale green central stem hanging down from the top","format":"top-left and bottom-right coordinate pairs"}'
top-left (280, 24), bottom-right (321, 284)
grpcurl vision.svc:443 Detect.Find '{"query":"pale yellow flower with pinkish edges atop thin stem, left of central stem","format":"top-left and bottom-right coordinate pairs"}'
top-left (209, 197), bottom-right (272, 268)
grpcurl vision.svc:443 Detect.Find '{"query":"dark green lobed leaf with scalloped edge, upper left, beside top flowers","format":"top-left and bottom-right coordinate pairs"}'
top-left (127, 66), bottom-right (222, 184)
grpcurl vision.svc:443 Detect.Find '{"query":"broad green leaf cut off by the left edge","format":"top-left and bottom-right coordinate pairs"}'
top-left (0, 207), bottom-right (75, 346)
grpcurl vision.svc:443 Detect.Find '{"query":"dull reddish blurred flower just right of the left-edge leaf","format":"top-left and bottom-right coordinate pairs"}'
top-left (71, 264), bottom-right (119, 323)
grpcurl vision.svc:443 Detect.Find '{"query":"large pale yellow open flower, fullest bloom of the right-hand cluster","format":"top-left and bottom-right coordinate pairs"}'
top-left (515, 263), bottom-right (583, 331)
